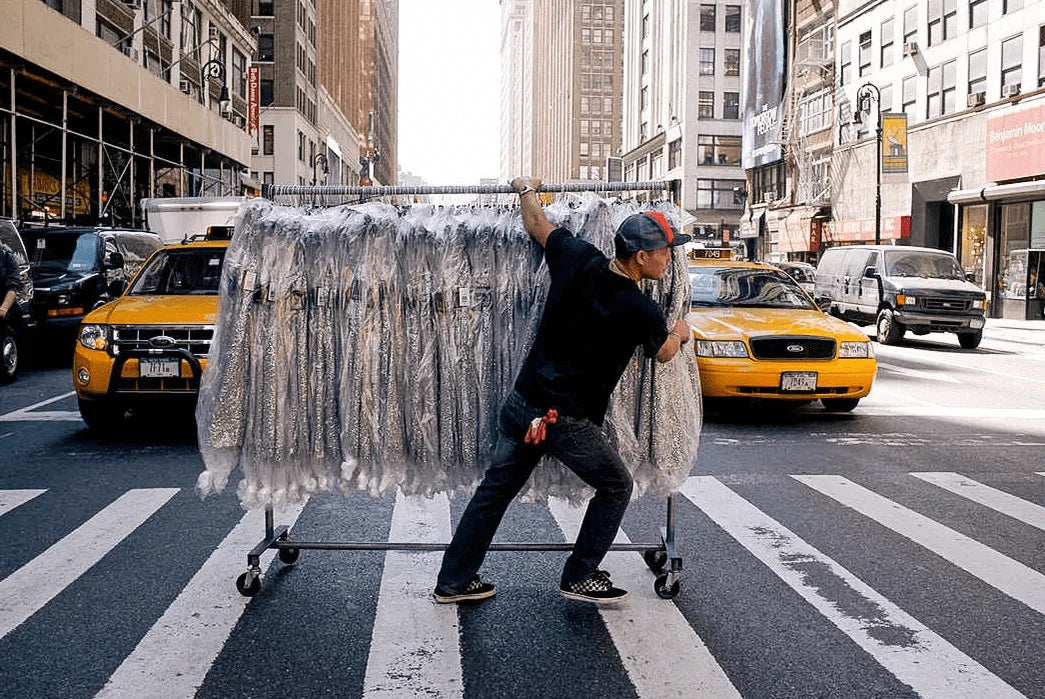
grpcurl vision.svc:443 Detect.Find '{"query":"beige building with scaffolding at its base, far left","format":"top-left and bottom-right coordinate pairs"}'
top-left (0, 0), bottom-right (257, 226)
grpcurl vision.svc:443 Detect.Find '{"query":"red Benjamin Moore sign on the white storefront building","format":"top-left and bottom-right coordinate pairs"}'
top-left (986, 104), bottom-right (1045, 182)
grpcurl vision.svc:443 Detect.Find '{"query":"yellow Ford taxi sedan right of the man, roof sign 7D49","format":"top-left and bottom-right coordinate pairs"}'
top-left (688, 249), bottom-right (878, 412)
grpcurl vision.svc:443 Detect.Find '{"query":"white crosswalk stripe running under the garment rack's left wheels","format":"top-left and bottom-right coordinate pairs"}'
top-left (97, 505), bottom-right (304, 698)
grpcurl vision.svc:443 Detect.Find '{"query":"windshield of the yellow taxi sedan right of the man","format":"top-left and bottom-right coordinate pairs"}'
top-left (690, 266), bottom-right (815, 309)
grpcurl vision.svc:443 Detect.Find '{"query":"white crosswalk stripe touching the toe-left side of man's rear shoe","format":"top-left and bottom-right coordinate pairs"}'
top-left (363, 491), bottom-right (464, 699)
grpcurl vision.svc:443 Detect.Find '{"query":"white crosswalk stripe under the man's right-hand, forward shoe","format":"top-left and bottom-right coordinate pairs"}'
top-left (549, 498), bottom-right (740, 698)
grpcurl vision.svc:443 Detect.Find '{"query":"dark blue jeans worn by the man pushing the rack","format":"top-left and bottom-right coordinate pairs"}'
top-left (437, 391), bottom-right (632, 592)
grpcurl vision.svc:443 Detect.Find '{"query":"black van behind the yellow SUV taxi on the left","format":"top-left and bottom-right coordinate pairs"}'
top-left (22, 227), bottom-right (163, 329)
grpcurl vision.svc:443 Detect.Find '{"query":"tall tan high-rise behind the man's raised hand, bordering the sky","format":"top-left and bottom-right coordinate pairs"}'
top-left (501, 0), bottom-right (624, 182)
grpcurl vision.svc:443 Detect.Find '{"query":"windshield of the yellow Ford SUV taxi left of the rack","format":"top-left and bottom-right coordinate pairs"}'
top-left (127, 248), bottom-right (225, 296)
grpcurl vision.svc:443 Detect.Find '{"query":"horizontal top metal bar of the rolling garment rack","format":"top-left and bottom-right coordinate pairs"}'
top-left (261, 180), bottom-right (676, 199)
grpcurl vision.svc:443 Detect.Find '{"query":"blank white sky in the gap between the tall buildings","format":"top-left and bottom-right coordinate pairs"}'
top-left (398, 0), bottom-right (501, 185)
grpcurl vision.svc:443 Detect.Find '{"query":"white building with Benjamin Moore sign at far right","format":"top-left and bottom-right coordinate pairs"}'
top-left (829, 0), bottom-right (1045, 319)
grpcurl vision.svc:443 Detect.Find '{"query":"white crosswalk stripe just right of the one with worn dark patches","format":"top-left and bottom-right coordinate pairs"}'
top-left (791, 475), bottom-right (1045, 614)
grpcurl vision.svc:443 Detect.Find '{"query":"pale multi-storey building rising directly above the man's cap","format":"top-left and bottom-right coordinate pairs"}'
top-left (623, 0), bottom-right (750, 243)
